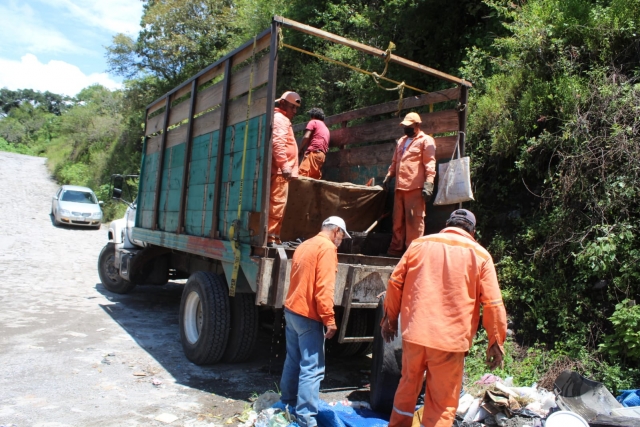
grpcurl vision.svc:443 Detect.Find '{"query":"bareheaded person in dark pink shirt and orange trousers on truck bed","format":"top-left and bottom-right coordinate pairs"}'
top-left (300, 108), bottom-right (330, 179)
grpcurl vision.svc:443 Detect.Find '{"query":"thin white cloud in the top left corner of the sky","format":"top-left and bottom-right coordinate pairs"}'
top-left (0, 2), bottom-right (90, 54)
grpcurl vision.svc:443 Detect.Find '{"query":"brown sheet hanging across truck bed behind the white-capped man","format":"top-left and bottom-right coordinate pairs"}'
top-left (280, 178), bottom-right (387, 241)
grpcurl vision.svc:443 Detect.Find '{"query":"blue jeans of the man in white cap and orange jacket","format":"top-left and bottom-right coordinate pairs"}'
top-left (280, 309), bottom-right (324, 427)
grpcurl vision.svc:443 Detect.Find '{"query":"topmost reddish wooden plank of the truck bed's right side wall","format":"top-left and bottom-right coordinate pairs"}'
top-left (293, 87), bottom-right (460, 132)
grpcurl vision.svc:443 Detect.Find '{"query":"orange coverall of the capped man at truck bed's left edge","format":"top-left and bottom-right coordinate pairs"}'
top-left (267, 107), bottom-right (298, 243)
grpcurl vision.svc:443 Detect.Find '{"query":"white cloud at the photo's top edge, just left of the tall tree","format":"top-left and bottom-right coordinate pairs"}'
top-left (46, 0), bottom-right (142, 35)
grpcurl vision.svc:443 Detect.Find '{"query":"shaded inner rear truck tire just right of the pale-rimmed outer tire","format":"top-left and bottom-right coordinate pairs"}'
top-left (222, 294), bottom-right (258, 363)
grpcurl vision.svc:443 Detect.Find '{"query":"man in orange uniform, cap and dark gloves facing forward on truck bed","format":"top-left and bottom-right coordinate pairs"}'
top-left (382, 113), bottom-right (436, 257)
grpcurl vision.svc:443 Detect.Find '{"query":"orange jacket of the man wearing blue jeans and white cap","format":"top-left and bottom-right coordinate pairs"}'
top-left (284, 234), bottom-right (338, 326)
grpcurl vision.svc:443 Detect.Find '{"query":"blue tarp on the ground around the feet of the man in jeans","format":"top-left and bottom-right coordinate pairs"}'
top-left (273, 400), bottom-right (389, 427)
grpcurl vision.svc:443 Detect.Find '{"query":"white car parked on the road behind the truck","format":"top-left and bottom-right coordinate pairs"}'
top-left (51, 185), bottom-right (102, 228)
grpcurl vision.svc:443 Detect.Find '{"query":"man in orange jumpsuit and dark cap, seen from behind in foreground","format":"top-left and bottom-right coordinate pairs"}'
top-left (381, 209), bottom-right (507, 427)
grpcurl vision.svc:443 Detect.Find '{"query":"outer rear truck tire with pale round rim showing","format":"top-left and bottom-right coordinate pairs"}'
top-left (180, 271), bottom-right (231, 365)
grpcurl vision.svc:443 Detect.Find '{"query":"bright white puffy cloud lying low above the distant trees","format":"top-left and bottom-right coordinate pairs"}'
top-left (0, 53), bottom-right (122, 96)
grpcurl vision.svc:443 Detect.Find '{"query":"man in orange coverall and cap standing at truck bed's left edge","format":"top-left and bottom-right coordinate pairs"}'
top-left (267, 91), bottom-right (302, 246)
